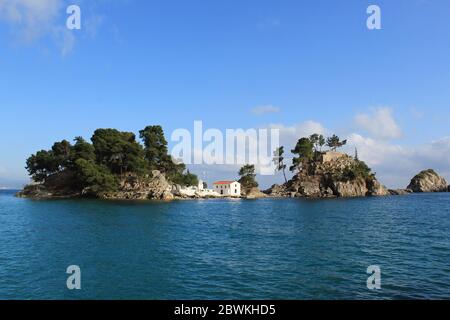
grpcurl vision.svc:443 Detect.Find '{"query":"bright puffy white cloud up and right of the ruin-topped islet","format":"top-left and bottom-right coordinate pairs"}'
top-left (354, 107), bottom-right (402, 140)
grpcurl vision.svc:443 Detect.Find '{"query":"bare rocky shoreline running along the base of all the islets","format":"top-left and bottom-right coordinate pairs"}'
top-left (16, 161), bottom-right (450, 201)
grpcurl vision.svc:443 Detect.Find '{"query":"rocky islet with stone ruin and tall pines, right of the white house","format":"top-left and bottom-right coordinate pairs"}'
top-left (265, 134), bottom-right (390, 198)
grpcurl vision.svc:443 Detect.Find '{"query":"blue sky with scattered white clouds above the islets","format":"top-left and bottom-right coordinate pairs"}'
top-left (0, 0), bottom-right (450, 187)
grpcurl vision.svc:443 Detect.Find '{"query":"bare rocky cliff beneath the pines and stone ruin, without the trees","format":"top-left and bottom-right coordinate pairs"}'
top-left (265, 153), bottom-right (389, 198)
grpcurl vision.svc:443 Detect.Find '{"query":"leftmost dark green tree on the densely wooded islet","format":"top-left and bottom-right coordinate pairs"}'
top-left (26, 150), bottom-right (59, 182)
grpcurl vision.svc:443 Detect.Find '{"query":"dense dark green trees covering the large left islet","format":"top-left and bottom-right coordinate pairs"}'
top-left (26, 126), bottom-right (198, 194)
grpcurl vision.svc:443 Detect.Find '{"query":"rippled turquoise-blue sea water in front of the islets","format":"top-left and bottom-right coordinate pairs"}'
top-left (0, 191), bottom-right (450, 299)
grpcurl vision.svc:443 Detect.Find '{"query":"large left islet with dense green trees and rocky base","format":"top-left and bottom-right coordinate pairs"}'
top-left (17, 126), bottom-right (198, 200)
